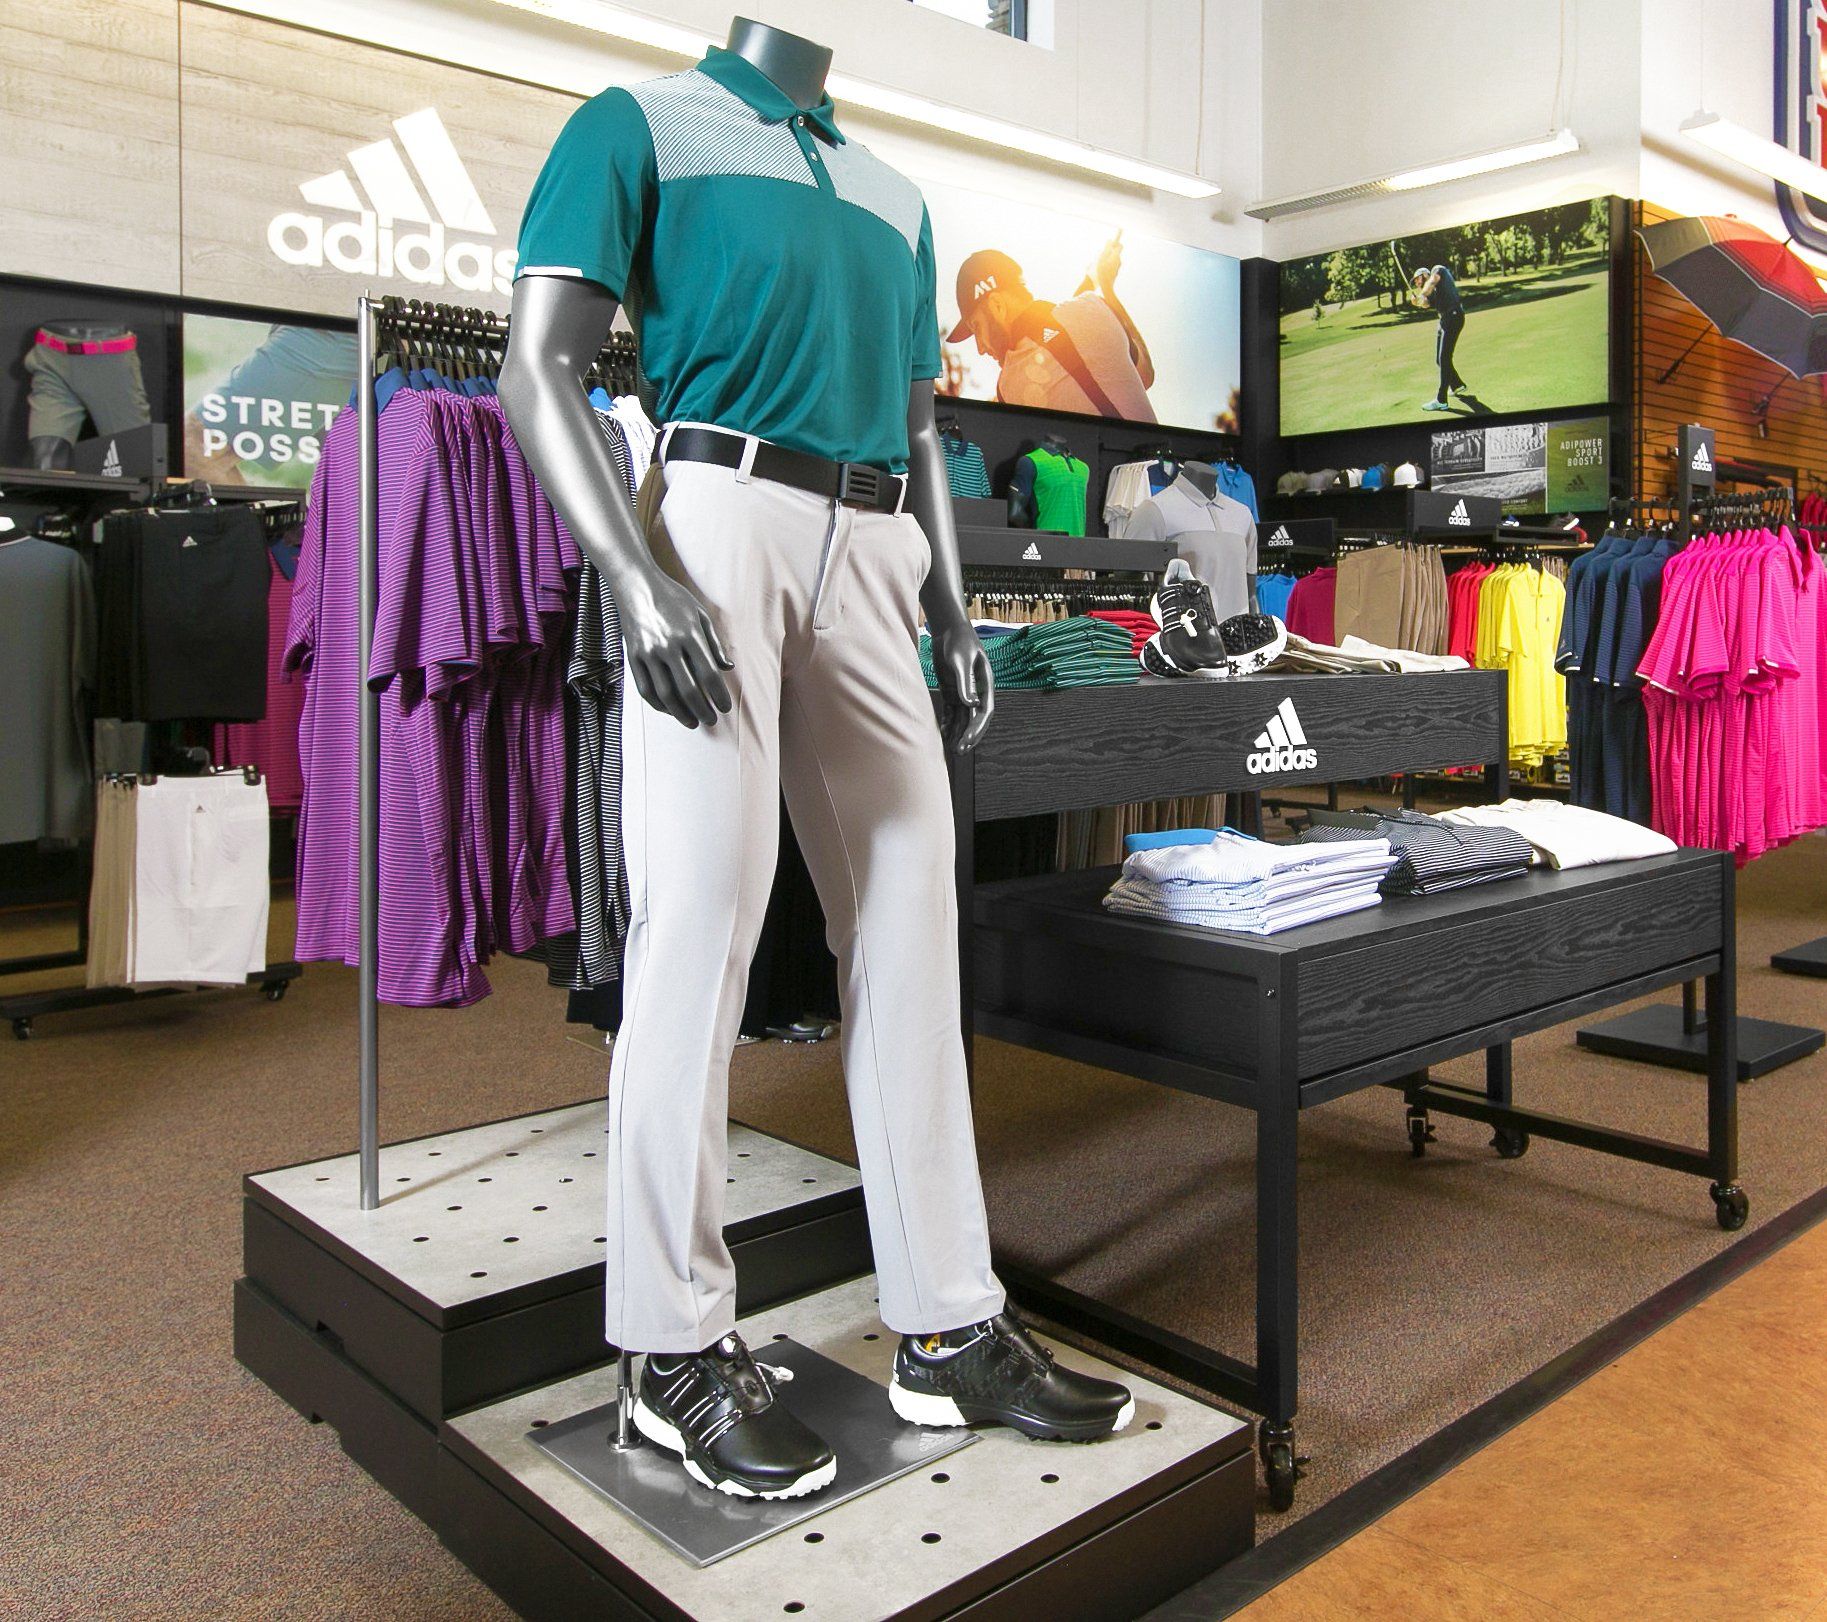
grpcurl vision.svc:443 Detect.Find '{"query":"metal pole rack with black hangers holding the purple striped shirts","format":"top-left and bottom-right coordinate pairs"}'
top-left (356, 292), bottom-right (639, 1211)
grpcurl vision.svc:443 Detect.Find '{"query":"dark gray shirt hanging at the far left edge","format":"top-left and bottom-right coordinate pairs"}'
top-left (0, 537), bottom-right (95, 844)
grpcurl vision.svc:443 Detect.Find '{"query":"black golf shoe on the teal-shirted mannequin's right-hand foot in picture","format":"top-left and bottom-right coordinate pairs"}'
top-left (888, 1311), bottom-right (1136, 1441)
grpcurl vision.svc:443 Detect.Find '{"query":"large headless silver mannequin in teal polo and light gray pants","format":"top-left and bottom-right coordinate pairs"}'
top-left (501, 18), bottom-right (1133, 1498)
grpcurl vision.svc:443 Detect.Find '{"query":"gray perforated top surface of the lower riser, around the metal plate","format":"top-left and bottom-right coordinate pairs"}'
top-left (448, 1279), bottom-right (1244, 1622)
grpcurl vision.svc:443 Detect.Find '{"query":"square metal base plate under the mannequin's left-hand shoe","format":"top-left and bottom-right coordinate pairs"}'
top-left (528, 1339), bottom-right (977, 1565)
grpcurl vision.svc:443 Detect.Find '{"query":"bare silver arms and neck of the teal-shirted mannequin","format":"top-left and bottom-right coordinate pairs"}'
top-left (501, 16), bottom-right (994, 751)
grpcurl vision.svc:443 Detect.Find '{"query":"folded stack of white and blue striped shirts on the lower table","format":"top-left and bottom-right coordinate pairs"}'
top-left (1104, 827), bottom-right (1394, 935)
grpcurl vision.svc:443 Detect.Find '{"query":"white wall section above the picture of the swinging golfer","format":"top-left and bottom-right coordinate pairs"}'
top-left (1251, 0), bottom-right (1644, 259)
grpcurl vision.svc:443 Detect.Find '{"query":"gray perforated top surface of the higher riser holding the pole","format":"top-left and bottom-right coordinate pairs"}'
top-left (248, 1103), bottom-right (861, 1310)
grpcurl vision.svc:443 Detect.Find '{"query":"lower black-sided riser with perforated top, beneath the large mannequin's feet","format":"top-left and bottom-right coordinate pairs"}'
top-left (236, 1277), bottom-right (1255, 1622)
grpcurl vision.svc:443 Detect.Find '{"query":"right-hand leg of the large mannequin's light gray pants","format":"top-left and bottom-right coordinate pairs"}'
top-left (780, 513), bottom-right (1003, 1333)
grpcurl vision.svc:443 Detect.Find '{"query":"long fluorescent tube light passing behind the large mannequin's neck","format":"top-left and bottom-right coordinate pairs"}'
top-left (495, 0), bottom-right (1219, 197)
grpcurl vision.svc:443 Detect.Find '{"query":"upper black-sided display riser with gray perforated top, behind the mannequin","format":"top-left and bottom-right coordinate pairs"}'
top-left (243, 1103), bottom-right (870, 1425)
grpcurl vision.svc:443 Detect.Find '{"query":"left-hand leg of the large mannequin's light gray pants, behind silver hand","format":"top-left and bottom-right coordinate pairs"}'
top-left (605, 464), bottom-right (780, 1353)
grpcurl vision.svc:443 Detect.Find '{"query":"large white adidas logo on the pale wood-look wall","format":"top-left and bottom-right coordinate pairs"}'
top-left (267, 108), bottom-right (515, 294)
